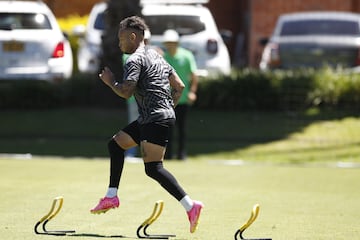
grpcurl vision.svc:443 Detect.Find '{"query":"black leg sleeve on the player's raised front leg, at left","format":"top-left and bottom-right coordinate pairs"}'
top-left (108, 138), bottom-right (125, 189)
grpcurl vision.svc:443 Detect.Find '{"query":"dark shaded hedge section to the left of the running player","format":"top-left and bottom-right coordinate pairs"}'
top-left (0, 74), bottom-right (125, 109)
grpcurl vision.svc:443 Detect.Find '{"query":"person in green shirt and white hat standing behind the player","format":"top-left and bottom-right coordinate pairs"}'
top-left (164, 29), bottom-right (198, 160)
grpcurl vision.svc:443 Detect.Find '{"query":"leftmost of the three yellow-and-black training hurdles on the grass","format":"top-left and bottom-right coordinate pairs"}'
top-left (34, 196), bottom-right (75, 236)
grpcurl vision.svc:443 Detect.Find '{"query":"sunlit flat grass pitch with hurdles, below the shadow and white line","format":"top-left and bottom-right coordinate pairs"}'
top-left (0, 156), bottom-right (360, 240)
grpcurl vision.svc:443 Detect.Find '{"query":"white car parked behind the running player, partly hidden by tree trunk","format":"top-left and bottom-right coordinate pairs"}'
top-left (78, 0), bottom-right (231, 77)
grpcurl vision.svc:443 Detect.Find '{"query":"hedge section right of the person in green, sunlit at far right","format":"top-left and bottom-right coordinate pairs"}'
top-left (196, 68), bottom-right (360, 110)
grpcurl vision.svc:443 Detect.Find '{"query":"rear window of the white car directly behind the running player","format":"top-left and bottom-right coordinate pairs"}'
top-left (144, 15), bottom-right (205, 35)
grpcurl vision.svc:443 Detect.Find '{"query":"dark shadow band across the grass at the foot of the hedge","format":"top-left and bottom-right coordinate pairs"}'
top-left (0, 109), bottom-right (351, 157)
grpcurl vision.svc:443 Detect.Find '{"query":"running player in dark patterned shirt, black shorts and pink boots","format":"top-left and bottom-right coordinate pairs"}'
top-left (90, 16), bottom-right (203, 233)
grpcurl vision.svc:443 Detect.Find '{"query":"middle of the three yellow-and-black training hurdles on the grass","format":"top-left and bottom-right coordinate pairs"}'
top-left (136, 200), bottom-right (176, 239)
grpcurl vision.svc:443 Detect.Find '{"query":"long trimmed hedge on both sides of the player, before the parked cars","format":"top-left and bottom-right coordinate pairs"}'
top-left (0, 69), bottom-right (360, 111)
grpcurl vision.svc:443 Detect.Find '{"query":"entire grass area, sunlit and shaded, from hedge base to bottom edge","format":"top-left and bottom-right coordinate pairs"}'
top-left (0, 109), bottom-right (360, 240)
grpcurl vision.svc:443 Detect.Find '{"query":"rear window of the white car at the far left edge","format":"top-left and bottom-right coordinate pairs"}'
top-left (0, 13), bottom-right (51, 30)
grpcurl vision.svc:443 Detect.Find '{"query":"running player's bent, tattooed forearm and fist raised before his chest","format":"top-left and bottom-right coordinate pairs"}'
top-left (99, 67), bottom-right (136, 99)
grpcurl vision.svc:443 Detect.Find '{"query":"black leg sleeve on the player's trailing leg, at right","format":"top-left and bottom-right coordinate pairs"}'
top-left (145, 161), bottom-right (186, 201)
